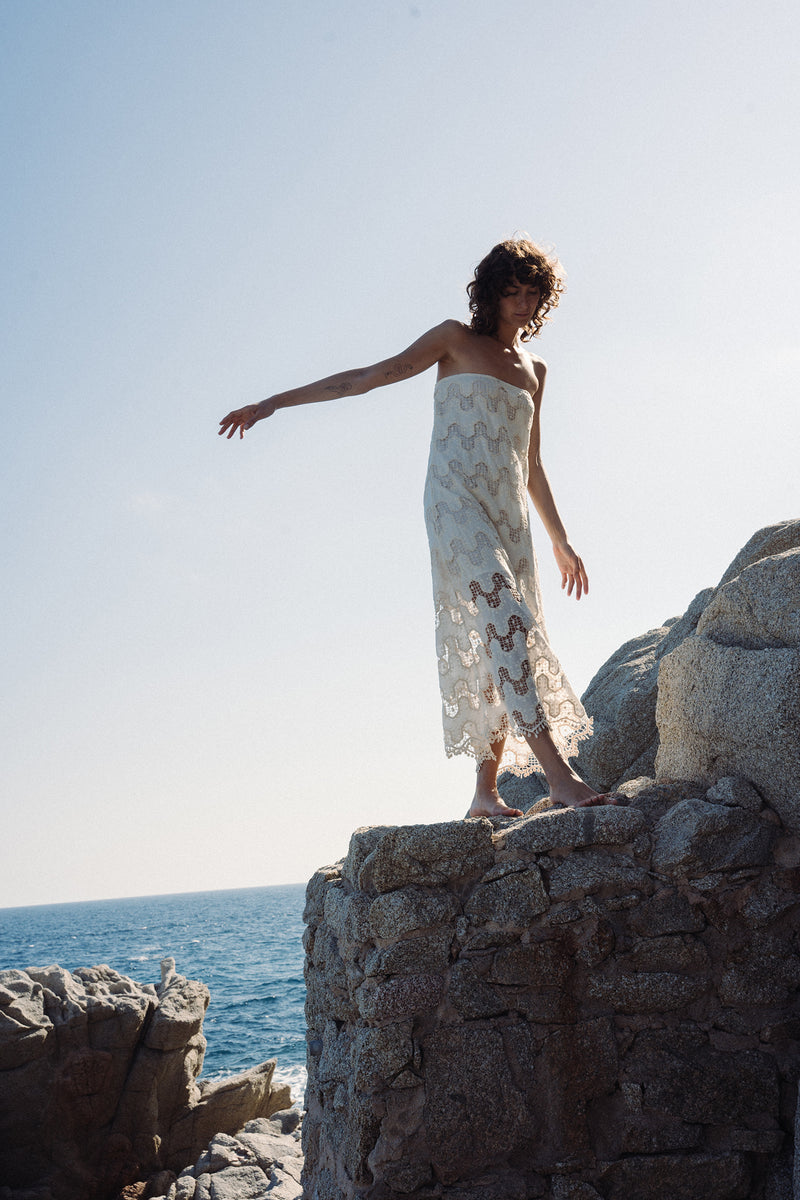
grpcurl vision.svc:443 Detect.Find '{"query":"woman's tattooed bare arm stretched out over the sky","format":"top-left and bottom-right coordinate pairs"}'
top-left (219, 320), bottom-right (458, 438)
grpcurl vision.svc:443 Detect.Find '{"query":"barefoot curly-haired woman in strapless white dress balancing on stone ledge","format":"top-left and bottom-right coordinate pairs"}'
top-left (219, 239), bottom-right (609, 817)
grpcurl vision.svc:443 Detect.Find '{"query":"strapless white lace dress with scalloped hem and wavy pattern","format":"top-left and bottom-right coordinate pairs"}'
top-left (425, 373), bottom-right (591, 775)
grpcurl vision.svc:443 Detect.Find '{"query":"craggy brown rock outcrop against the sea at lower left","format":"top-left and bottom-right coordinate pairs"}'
top-left (0, 959), bottom-right (291, 1200)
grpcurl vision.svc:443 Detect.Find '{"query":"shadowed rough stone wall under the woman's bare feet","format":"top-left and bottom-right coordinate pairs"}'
top-left (303, 776), bottom-right (800, 1200)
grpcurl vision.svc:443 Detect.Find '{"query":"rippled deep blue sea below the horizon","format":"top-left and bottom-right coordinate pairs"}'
top-left (0, 883), bottom-right (306, 1104)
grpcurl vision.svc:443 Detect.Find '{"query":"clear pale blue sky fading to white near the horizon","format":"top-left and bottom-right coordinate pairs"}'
top-left (0, 0), bottom-right (800, 906)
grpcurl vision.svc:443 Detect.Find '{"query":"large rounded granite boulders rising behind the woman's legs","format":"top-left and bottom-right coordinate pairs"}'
top-left (568, 521), bottom-right (800, 796)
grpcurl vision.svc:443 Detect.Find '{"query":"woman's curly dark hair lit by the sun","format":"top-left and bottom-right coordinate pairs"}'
top-left (467, 238), bottom-right (564, 342)
